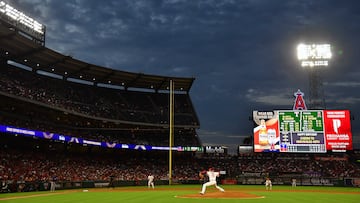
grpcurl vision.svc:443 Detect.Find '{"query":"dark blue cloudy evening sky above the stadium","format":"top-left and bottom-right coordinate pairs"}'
top-left (5, 0), bottom-right (360, 152)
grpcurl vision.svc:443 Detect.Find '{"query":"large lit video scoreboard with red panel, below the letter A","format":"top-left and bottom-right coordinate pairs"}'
top-left (253, 110), bottom-right (352, 153)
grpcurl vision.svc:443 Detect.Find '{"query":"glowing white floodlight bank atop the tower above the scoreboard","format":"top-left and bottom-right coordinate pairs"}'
top-left (297, 44), bottom-right (332, 67)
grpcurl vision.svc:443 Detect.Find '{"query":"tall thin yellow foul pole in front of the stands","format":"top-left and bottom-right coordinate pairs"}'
top-left (169, 80), bottom-right (174, 185)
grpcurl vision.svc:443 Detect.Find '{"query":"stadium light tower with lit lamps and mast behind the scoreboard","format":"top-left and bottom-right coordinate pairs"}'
top-left (297, 44), bottom-right (332, 109)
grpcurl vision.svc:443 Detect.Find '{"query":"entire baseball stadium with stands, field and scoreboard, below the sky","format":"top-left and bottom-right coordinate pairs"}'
top-left (0, 1), bottom-right (360, 203)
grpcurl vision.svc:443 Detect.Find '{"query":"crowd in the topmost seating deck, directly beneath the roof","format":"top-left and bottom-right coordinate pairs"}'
top-left (0, 65), bottom-right (198, 126)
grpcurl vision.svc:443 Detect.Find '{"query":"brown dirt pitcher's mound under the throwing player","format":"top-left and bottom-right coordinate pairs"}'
top-left (177, 191), bottom-right (264, 199)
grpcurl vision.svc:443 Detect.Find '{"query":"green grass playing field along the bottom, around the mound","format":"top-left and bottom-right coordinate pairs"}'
top-left (0, 185), bottom-right (360, 203)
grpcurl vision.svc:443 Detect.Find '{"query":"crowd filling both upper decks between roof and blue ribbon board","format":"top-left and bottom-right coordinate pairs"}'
top-left (0, 63), bottom-right (200, 146)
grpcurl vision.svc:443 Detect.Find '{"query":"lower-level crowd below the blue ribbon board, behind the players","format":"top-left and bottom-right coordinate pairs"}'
top-left (0, 134), bottom-right (360, 192)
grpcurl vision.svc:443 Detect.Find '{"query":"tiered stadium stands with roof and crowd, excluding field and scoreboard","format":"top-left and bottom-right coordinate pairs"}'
top-left (0, 2), bottom-right (360, 192)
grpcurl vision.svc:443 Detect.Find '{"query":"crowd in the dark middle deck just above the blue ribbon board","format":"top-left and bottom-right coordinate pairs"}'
top-left (0, 96), bottom-right (200, 146)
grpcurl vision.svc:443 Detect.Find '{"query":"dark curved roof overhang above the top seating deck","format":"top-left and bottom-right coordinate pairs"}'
top-left (0, 19), bottom-right (195, 93)
